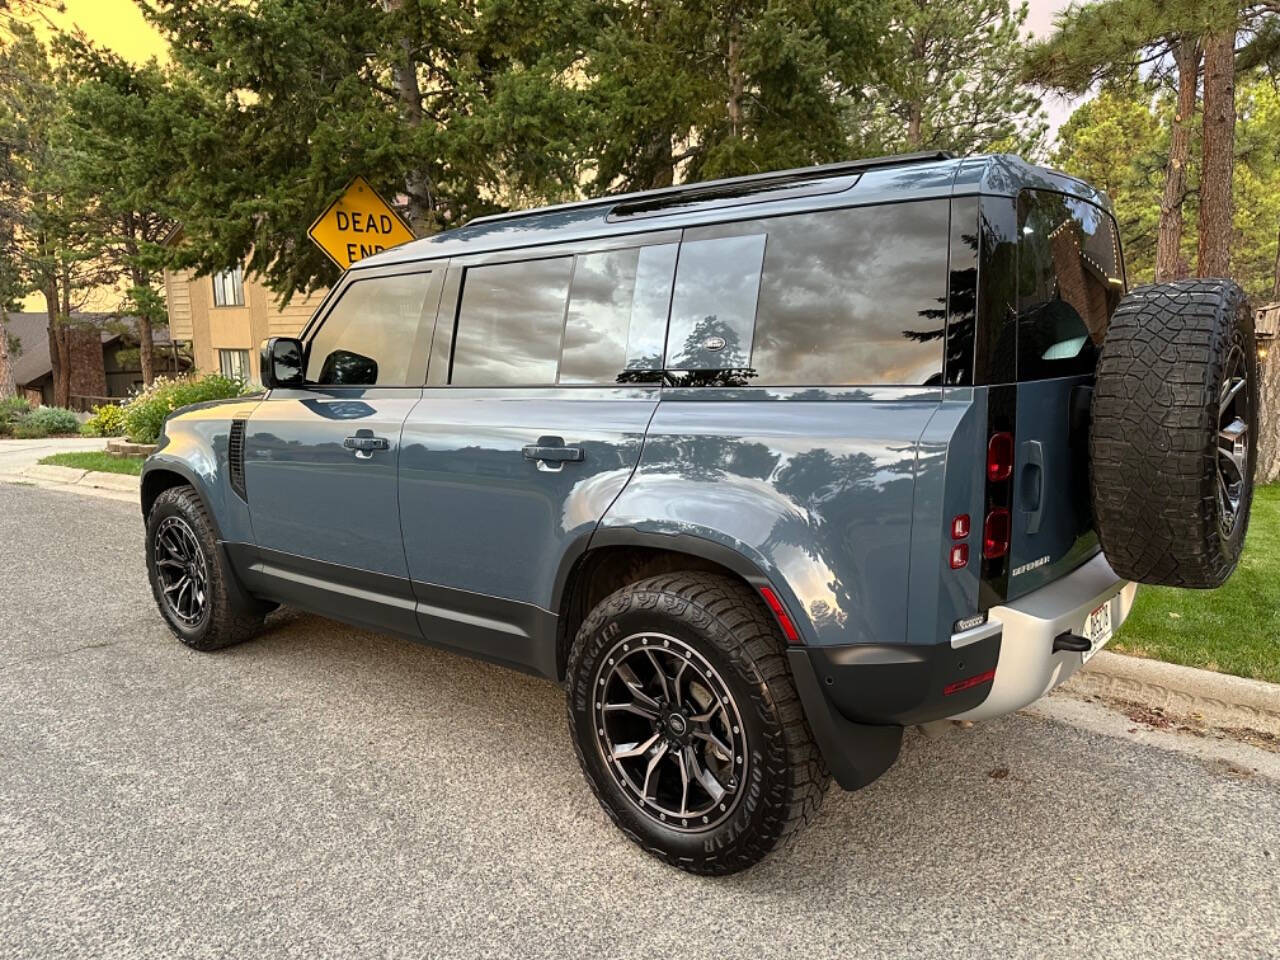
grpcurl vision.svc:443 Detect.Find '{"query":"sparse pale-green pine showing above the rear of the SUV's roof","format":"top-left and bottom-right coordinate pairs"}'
top-left (846, 0), bottom-right (1047, 156)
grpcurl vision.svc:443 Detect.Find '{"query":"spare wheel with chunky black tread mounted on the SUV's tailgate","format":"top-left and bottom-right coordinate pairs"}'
top-left (1089, 279), bottom-right (1258, 588)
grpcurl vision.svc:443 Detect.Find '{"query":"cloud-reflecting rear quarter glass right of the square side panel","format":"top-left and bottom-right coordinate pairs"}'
top-left (751, 200), bottom-right (948, 387)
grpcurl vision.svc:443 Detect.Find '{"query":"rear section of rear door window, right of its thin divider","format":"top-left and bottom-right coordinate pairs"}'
top-left (559, 243), bottom-right (676, 384)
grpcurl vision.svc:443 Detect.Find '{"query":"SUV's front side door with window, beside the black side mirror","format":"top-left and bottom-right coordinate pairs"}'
top-left (244, 265), bottom-right (444, 635)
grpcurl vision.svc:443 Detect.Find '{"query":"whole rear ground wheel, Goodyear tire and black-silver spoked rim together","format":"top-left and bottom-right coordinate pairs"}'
top-left (568, 572), bottom-right (831, 874)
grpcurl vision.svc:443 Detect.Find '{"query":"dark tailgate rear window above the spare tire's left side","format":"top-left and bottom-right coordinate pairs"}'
top-left (1018, 191), bottom-right (1124, 380)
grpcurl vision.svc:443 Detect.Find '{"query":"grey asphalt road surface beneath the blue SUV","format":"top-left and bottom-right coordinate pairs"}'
top-left (0, 484), bottom-right (1280, 959)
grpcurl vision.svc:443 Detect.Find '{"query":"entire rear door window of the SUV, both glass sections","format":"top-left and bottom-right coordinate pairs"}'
top-left (449, 243), bottom-right (676, 387)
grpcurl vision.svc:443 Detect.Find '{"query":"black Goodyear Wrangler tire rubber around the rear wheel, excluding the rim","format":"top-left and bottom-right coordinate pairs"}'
top-left (567, 572), bottom-right (831, 876)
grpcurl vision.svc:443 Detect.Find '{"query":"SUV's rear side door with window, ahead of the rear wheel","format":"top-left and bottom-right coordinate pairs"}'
top-left (399, 230), bottom-right (680, 676)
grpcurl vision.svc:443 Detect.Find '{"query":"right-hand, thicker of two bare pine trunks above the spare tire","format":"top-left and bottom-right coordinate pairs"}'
top-left (1196, 27), bottom-right (1235, 276)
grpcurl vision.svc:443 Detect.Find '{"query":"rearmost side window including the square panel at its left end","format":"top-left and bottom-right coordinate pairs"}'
top-left (667, 200), bottom-right (950, 387)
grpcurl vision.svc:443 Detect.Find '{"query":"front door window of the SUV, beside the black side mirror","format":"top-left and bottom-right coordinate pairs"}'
top-left (307, 274), bottom-right (431, 387)
